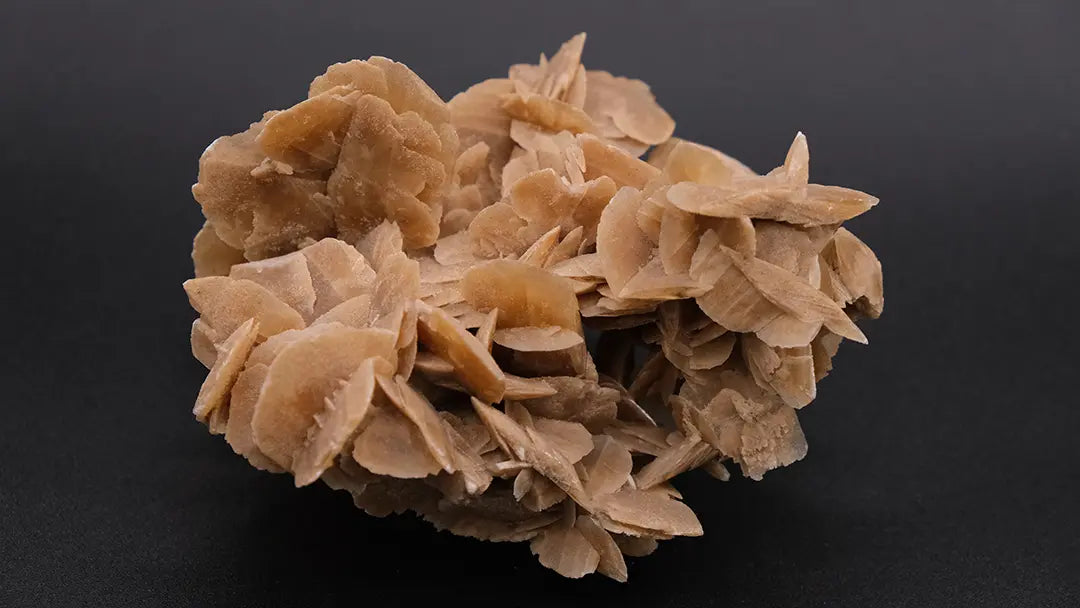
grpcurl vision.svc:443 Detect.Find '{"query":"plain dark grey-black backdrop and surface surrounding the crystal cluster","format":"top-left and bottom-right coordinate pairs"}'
top-left (0, 0), bottom-right (1080, 607)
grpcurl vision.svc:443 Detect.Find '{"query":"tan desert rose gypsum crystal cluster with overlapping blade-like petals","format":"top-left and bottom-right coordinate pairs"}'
top-left (184, 35), bottom-right (883, 581)
